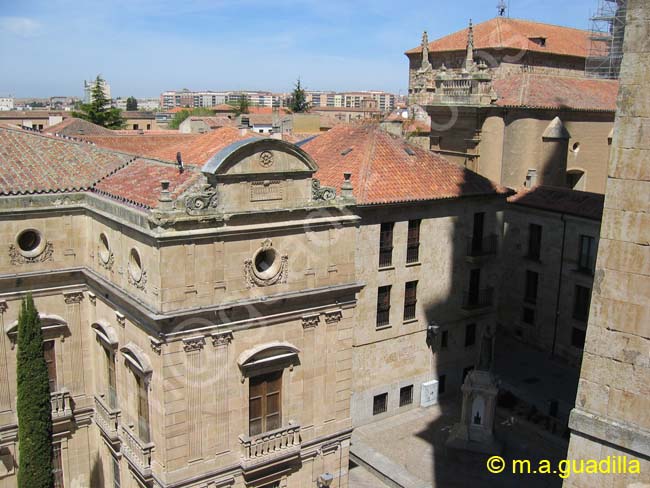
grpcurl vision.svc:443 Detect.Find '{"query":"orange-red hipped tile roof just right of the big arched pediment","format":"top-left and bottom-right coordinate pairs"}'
top-left (301, 125), bottom-right (506, 204)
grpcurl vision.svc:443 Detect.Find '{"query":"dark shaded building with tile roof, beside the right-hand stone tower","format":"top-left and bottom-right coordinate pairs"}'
top-left (498, 186), bottom-right (603, 366)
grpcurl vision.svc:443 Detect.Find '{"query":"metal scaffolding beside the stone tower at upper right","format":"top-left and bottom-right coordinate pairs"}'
top-left (585, 0), bottom-right (627, 79)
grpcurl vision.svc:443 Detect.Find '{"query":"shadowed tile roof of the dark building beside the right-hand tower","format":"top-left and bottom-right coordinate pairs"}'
top-left (508, 186), bottom-right (605, 221)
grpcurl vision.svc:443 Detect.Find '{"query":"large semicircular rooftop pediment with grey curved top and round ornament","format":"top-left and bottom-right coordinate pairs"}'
top-left (201, 137), bottom-right (318, 177)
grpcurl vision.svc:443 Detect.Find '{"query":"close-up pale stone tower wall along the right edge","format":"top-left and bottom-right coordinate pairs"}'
top-left (564, 0), bottom-right (650, 488)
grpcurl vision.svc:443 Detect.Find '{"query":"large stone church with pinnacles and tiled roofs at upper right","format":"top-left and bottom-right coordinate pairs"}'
top-left (406, 18), bottom-right (618, 193)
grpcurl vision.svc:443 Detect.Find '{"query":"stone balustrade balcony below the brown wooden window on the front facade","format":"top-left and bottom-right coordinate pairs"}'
top-left (239, 422), bottom-right (300, 470)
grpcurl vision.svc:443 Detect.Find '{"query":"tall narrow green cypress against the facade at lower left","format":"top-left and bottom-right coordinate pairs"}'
top-left (16, 294), bottom-right (54, 488)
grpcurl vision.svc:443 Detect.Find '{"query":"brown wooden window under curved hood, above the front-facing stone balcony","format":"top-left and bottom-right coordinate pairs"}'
top-left (248, 371), bottom-right (282, 436)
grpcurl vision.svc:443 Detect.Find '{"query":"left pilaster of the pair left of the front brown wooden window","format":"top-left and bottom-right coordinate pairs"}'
top-left (183, 336), bottom-right (205, 461)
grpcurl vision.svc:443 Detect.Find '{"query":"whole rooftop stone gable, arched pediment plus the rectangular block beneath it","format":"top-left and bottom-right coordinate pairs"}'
top-left (202, 138), bottom-right (330, 213)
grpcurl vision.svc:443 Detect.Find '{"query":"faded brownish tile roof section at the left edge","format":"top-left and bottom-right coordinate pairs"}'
top-left (0, 127), bottom-right (133, 195)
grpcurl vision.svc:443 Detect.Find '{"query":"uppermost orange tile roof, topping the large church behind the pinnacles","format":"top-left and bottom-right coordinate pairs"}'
top-left (405, 17), bottom-right (589, 58)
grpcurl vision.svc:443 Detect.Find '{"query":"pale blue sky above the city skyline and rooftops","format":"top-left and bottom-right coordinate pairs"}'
top-left (0, 0), bottom-right (597, 97)
